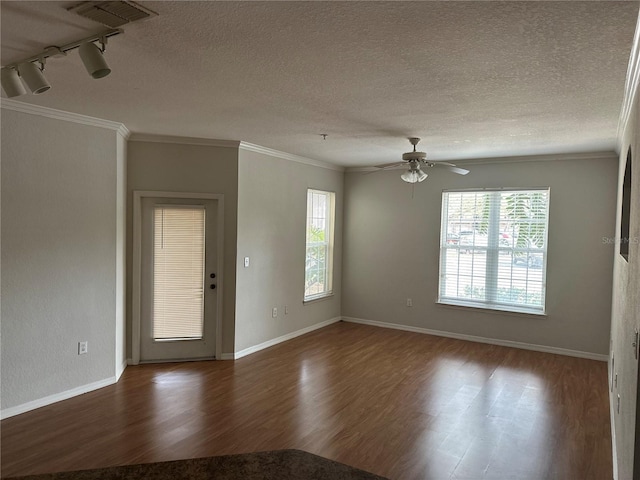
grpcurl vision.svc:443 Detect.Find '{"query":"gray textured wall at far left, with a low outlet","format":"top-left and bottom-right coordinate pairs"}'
top-left (1, 108), bottom-right (124, 411)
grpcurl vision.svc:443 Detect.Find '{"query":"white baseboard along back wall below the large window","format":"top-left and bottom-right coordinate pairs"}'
top-left (342, 317), bottom-right (609, 362)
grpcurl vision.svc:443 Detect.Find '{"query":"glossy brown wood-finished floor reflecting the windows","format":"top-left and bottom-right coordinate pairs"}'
top-left (0, 323), bottom-right (612, 480)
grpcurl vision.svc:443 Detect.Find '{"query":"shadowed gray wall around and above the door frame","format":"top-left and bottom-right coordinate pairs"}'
top-left (127, 141), bottom-right (238, 358)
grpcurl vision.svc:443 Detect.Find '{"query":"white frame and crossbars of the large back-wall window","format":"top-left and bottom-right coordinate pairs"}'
top-left (436, 187), bottom-right (550, 316)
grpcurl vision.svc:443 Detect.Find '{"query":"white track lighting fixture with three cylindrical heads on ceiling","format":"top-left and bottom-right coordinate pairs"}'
top-left (1, 28), bottom-right (124, 97)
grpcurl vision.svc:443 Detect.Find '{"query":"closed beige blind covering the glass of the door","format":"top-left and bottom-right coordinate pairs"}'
top-left (152, 205), bottom-right (205, 341)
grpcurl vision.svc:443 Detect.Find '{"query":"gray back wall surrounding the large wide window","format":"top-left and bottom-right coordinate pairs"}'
top-left (342, 152), bottom-right (617, 355)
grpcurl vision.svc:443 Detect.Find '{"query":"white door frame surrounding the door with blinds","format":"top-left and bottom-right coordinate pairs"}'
top-left (131, 190), bottom-right (224, 365)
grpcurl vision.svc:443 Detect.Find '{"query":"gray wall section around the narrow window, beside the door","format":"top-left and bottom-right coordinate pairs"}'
top-left (235, 149), bottom-right (344, 352)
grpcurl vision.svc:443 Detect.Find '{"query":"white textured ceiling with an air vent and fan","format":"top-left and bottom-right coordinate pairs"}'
top-left (0, 1), bottom-right (639, 166)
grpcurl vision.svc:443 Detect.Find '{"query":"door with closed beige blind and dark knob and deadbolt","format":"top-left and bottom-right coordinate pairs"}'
top-left (140, 197), bottom-right (218, 362)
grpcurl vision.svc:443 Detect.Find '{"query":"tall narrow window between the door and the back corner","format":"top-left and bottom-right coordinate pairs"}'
top-left (304, 189), bottom-right (335, 301)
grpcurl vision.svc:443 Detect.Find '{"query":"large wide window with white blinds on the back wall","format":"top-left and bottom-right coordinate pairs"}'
top-left (438, 188), bottom-right (549, 314)
